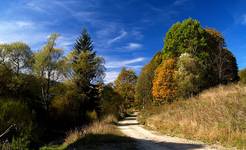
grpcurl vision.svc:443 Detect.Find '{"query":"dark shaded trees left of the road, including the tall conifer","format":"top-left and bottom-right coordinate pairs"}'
top-left (0, 30), bottom-right (124, 149)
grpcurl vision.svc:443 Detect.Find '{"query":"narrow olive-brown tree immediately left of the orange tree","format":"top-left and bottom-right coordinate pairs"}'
top-left (135, 52), bottom-right (162, 106)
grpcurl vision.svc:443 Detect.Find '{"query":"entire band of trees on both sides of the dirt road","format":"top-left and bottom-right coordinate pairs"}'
top-left (0, 18), bottom-right (246, 149)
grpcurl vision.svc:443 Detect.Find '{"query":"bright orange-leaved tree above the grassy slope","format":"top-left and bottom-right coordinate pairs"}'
top-left (152, 58), bottom-right (177, 103)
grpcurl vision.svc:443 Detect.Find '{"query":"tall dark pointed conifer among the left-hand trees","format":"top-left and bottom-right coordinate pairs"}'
top-left (72, 30), bottom-right (105, 123)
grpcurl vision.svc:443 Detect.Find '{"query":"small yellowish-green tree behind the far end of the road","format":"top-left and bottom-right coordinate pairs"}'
top-left (114, 67), bottom-right (137, 109)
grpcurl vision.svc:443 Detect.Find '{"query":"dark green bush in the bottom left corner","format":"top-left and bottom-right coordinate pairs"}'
top-left (0, 98), bottom-right (33, 149)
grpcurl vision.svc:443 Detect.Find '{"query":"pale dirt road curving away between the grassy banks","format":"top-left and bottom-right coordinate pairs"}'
top-left (118, 115), bottom-right (225, 150)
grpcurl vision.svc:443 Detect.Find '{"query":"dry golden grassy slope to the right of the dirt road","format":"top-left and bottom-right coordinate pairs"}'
top-left (139, 84), bottom-right (246, 149)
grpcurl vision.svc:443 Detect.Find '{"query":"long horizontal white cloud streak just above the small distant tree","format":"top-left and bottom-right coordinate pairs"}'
top-left (105, 57), bottom-right (145, 69)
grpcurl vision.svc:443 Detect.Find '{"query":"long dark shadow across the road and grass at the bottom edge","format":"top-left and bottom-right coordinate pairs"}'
top-left (68, 134), bottom-right (204, 150)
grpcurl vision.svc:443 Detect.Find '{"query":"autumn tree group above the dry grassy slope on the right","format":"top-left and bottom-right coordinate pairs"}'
top-left (115, 18), bottom-right (239, 108)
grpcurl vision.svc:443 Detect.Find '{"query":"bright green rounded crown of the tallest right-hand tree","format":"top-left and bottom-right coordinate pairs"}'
top-left (163, 18), bottom-right (207, 57)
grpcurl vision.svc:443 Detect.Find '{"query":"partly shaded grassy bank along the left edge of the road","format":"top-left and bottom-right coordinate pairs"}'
top-left (41, 116), bottom-right (136, 150)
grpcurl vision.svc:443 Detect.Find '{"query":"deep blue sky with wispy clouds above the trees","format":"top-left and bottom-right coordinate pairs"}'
top-left (0, 0), bottom-right (246, 82)
